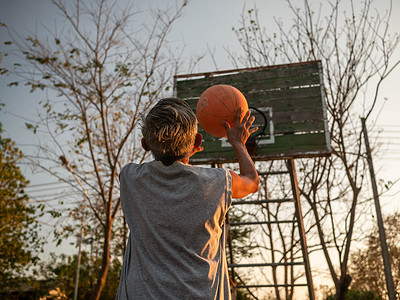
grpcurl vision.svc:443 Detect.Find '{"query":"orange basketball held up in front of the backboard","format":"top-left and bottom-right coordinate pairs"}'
top-left (196, 84), bottom-right (249, 137)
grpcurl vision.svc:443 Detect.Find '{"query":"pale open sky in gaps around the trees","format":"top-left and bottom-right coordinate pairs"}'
top-left (0, 0), bottom-right (400, 296)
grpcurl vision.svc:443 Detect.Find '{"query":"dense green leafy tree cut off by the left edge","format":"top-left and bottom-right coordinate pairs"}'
top-left (0, 119), bottom-right (41, 288)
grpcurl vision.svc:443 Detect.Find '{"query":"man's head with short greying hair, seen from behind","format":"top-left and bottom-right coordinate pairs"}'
top-left (142, 98), bottom-right (197, 165)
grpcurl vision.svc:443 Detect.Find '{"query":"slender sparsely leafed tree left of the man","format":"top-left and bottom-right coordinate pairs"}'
top-left (1, 0), bottom-right (191, 299)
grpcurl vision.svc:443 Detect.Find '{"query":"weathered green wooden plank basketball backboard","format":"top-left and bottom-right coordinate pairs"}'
top-left (174, 61), bottom-right (331, 164)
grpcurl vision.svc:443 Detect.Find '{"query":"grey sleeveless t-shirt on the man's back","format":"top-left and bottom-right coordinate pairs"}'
top-left (116, 161), bottom-right (232, 300)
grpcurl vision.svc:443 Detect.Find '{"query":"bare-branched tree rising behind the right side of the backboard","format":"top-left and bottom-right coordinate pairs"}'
top-left (229, 0), bottom-right (400, 299)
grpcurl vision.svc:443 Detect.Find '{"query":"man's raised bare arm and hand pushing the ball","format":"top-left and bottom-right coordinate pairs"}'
top-left (223, 109), bottom-right (259, 198)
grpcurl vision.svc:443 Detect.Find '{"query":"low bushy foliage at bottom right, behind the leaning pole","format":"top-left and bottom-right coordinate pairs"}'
top-left (350, 213), bottom-right (400, 299)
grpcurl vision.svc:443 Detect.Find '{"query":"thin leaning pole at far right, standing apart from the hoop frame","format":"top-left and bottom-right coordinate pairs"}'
top-left (361, 118), bottom-right (396, 300)
